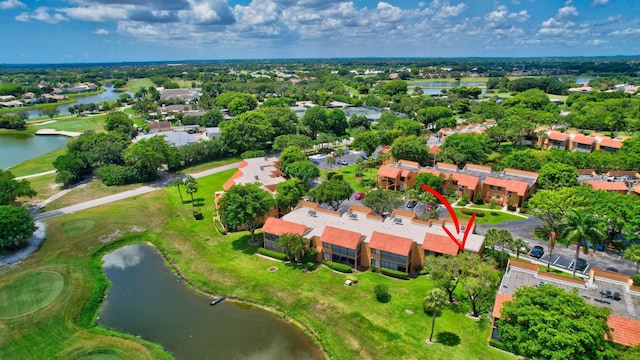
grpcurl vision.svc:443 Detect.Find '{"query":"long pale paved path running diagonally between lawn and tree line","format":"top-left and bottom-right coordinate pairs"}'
top-left (34, 162), bottom-right (240, 221)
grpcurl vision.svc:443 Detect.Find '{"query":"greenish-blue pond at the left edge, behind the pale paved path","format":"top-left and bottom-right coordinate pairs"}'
top-left (0, 134), bottom-right (70, 169)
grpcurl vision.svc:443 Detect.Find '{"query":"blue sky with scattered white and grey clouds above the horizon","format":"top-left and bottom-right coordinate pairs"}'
top-left (0, 0), bottom-right (640, 64)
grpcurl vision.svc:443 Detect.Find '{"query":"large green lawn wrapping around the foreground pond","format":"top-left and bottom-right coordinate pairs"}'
top-left (0, 170), bottom-right (514, 359)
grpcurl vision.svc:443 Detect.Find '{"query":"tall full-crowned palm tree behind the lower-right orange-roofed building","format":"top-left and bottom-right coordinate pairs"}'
top-left (561, 209), bottom-right (606, 278)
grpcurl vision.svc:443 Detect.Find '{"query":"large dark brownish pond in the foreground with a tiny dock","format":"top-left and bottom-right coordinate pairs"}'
top-left (98, 244), bottom-right (323, 360)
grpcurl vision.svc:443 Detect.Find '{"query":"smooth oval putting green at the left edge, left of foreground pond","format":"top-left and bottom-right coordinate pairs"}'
top-left (0, 271), bottom-right (64, 319)
